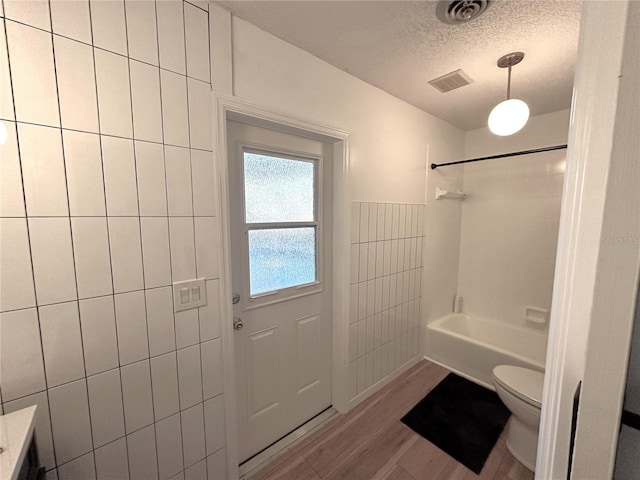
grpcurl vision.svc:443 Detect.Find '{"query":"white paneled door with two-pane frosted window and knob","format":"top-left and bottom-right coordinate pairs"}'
top-left (227, 122), bottom-right (331, 463)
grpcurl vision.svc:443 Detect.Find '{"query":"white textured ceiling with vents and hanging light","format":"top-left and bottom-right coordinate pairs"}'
top-left (217, 0), bottom-right (580, 130)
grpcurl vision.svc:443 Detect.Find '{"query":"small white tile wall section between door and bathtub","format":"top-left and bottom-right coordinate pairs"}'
top-left (349, 202), bottom-right (424, 398)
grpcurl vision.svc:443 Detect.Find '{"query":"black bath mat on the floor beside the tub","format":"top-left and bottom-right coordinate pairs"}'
top-left (402, 373), bottom-right (510, 473)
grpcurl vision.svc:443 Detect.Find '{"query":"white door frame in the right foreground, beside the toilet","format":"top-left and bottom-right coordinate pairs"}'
top-left (536, 0), bottom-right (640, 479)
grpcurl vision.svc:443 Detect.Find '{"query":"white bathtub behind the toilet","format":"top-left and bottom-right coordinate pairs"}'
top-left (425, 314), bottom-right (547, 389)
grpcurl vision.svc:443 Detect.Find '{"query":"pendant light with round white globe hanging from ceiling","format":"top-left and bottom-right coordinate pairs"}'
top-left (488, 52), bottom-right (529, 137)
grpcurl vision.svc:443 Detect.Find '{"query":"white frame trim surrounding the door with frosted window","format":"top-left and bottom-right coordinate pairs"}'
top-left (212, 92), bottom-right (351, 480)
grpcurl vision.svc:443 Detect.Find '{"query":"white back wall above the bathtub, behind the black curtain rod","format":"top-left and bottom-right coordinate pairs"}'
top-left (458, 110), bottom-right (569, 334)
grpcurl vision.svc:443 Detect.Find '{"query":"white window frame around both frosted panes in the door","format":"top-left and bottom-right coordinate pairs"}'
top-left (238, 142), bottom-right (324, 310)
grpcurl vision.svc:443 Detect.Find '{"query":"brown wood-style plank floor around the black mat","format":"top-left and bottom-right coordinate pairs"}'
top-left (250, 360), bottom-right (533, 480)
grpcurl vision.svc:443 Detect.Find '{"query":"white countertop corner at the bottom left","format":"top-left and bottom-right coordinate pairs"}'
top-left (0, 405), bottom-right (37, 480)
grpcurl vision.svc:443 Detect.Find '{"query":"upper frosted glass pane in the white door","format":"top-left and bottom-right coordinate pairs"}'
top-left (244, 151), bottom-right (315, 223)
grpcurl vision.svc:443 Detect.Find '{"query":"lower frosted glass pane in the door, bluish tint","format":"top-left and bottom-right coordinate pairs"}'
top-left (248, 227), bottom-right (317, 295)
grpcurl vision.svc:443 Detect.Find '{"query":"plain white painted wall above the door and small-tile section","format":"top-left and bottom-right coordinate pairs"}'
top-left (232, 17), bottom-right (463, 204)
